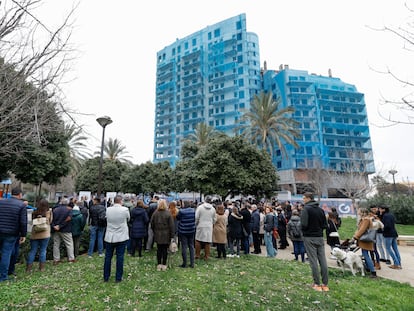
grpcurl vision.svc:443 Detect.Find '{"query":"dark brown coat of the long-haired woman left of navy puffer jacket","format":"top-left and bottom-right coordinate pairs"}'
top-left (151, 209), bottom-right (175, 244)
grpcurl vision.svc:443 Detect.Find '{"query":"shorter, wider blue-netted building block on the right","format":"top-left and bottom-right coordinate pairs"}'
top-left (263, 65), bottom-right (375, 197)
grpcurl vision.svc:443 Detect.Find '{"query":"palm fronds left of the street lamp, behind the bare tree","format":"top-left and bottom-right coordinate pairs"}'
top-left (64, 123), bottom-right (91, 175)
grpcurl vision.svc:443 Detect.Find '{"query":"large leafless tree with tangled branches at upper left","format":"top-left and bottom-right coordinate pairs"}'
top-left (0, 0), bottom-right (76, 156)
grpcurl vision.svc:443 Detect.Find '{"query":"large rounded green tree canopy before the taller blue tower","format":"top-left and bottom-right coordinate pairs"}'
top-left (174, 136), bottom-right (278, 197)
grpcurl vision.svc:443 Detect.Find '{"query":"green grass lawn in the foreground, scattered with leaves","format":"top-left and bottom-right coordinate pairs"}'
top-left (0, 245), bottom-right (414, 311)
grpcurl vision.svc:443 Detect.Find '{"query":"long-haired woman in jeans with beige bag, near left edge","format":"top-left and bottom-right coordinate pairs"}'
top-left (26, 199), bottom-right (52, 273)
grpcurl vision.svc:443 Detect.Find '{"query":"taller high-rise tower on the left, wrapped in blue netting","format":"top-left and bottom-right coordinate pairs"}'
top-left (154, 14), bottom-right (261, 166)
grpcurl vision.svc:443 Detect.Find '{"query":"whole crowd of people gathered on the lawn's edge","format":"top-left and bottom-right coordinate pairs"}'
top-left (0, 188), bottom-right (402, 291)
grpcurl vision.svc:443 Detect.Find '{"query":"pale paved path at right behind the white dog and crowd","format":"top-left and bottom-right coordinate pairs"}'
top-left (262, 241), bottom-right (414, 287)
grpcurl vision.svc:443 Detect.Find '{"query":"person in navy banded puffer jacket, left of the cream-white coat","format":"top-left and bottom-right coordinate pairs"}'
top-left (177, 200), bottom-right (195, 268)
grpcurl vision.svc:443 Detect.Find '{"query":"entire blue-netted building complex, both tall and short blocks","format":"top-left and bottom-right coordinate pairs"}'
top-left (153, 14), bottom-right (375, 197)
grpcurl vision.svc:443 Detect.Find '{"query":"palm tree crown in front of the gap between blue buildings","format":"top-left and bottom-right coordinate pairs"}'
top-left (239, 92), bottom-right (300, 156)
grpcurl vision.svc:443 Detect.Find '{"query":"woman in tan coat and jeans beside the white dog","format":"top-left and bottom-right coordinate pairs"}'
top-left (351, 207), bottom-right (377, 278)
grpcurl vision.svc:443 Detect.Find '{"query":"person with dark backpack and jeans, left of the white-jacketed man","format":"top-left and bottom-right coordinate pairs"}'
top-left (88, 197), bottom-right (106, 258)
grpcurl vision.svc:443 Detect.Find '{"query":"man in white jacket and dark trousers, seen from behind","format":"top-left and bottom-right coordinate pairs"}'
top-left (103, 195), bottom-right (130, 283)
